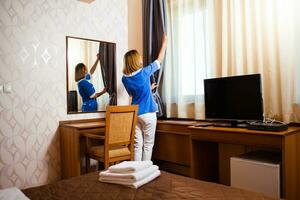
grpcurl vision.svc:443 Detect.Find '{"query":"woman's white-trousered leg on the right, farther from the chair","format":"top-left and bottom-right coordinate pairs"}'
top-left (142, 112), bottom-right (157, 160)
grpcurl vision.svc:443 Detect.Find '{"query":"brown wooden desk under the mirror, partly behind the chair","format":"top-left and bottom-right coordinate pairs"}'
top-left (60, 120), bottom-right (105, 178)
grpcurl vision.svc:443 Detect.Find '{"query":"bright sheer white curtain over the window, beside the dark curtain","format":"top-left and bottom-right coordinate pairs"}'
top-left (163, 0), bottom-right (211, 118)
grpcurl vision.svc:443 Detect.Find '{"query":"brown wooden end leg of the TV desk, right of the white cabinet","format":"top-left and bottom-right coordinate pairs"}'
top-left (282, 133), bottom-right (300, 200)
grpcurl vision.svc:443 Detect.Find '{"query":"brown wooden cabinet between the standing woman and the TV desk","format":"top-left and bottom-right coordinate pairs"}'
top-left (152, 120), bottom-right (195, 176)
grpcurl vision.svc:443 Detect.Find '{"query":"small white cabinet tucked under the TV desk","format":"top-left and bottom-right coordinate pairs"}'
top-left (230, 151), bottom-right (281, 198)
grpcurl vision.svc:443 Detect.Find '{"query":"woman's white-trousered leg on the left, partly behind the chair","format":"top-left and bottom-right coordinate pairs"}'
top-left (134, 117), bottom-right (143, 161)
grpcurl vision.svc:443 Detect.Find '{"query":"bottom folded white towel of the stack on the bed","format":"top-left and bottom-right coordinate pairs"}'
top-left (99, 165), bottom-right (158, 183)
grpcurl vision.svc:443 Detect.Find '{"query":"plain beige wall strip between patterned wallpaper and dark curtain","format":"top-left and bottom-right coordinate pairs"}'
top-left (128, 0), bottom-right (143, 54)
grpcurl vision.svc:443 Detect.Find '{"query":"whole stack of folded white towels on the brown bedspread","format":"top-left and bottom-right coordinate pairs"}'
top-left (99, 161), bottom-right (160, 188)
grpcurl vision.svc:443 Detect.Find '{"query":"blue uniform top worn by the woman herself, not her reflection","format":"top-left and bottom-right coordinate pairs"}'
top-left (122, 60), bottom-right (160, 115)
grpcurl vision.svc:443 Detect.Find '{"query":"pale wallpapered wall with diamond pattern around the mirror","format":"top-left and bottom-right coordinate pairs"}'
top-left (0, 0), bottom-right (128, 188)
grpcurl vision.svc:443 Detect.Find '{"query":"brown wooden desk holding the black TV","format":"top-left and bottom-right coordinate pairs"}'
top-left (189, 126), bottom-right (300, 200)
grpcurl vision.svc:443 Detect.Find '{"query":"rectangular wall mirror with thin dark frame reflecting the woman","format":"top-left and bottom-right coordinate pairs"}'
top-left (66, 36), bottom-right (117, 114)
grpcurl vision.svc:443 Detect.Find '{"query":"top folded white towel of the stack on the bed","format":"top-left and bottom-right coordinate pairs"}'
top-left (108, 161), bottom-right (153, 173)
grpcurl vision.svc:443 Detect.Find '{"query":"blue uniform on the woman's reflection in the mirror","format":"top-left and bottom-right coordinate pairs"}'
top-left (78, 74), bottom-right (97, 112)
